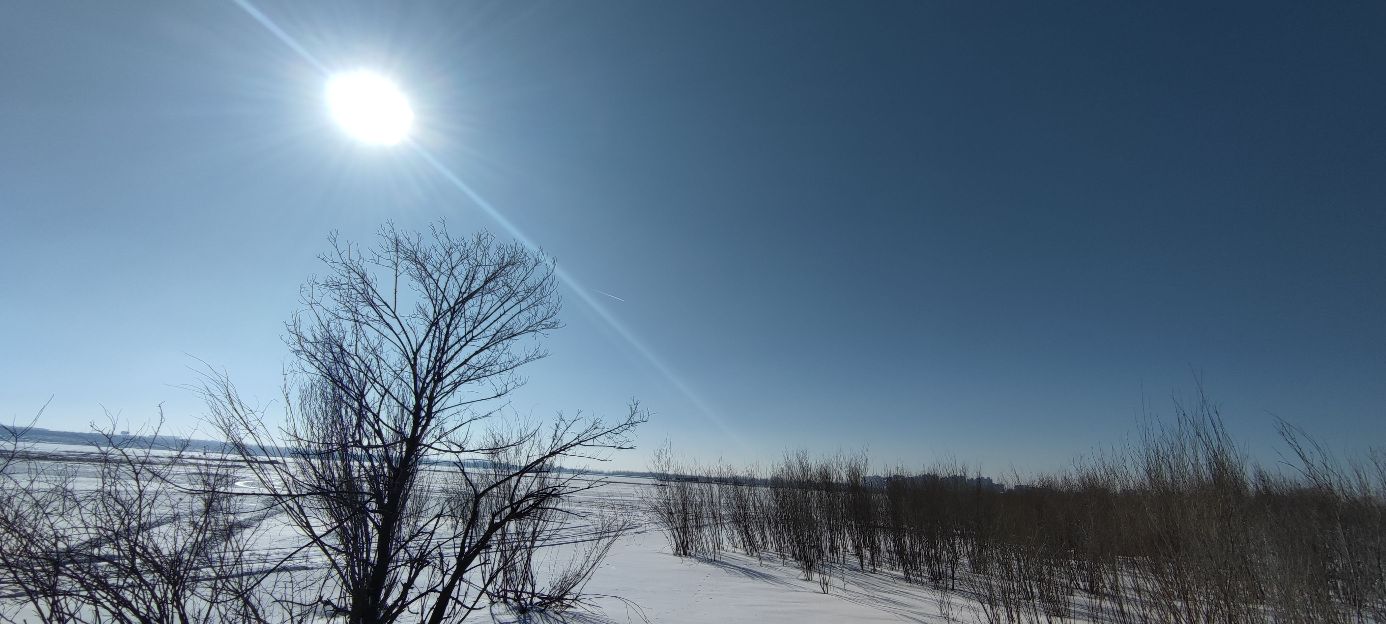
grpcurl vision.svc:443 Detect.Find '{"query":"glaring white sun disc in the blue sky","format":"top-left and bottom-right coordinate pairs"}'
top-left (327, 69), bottom-right (414, 146)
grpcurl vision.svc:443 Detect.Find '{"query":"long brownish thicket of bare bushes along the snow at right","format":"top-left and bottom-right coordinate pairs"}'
top-left (653, 388), bottom-right (1386, 623)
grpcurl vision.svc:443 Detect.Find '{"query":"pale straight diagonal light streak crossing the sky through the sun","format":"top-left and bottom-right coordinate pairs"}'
top-left (231, 0), bottom-right (750, 451)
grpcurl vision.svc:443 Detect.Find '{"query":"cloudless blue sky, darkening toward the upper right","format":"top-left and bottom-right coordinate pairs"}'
top-left (0, 0), bottom-right (1386, 473)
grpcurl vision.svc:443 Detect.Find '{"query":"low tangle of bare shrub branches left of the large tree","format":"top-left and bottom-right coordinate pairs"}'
top-left (0, 416), bottom-right (269, 624)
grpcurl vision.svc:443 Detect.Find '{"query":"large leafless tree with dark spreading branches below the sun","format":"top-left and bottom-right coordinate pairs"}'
top-left (204, 226), bottom-right (644, 624)
